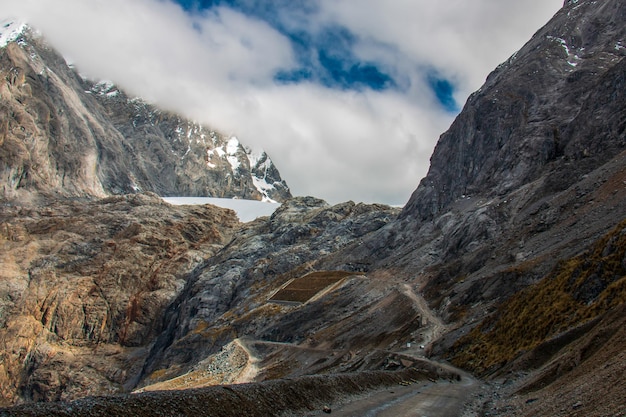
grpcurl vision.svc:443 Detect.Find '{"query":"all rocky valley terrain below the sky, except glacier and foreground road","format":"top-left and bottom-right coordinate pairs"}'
top-left (0, 0), bottom-right (626, 416)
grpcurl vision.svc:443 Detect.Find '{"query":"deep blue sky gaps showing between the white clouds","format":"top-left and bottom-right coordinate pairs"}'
top-left (176, 0), bottom-right (459, 109)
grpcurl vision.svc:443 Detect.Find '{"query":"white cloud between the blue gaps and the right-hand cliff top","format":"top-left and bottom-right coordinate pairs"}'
top-left (321, 0), bottom-right (562, 102)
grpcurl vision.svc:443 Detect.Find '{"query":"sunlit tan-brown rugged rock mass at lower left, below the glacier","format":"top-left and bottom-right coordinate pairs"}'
top-left (0, 194), bottom-right (239, 404)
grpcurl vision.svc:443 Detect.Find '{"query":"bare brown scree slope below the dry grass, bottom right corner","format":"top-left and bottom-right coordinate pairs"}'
top-left (486, 303), bottom-right (626, 417)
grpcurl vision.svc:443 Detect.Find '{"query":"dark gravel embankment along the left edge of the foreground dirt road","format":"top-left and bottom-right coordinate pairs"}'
top-left (0, 363), bottom-right (460, 417)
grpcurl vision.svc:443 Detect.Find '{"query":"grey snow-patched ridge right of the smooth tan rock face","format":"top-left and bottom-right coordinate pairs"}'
top-left (82, 80), bottom-right (291, 201)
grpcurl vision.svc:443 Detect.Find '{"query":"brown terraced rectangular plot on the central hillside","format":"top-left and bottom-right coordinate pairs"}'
top-left (270, 271), bottom-right (354, 303)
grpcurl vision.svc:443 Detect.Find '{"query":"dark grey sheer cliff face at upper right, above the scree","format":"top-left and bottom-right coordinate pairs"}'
top-left (403, 1), bottom-right (626, 219)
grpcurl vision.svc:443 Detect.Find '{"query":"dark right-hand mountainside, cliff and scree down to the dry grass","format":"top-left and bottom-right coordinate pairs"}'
top-left (324, 1), bottom-right (626, 320)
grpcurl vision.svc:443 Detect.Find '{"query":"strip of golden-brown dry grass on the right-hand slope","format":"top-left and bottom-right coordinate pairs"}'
top-left (452, 221), bottom-right (626, 373)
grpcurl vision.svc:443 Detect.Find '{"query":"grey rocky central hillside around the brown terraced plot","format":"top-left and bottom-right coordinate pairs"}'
top-left (135, 197), bottom-right (404, 384)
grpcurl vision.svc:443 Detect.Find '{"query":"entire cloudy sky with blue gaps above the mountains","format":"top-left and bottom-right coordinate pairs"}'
top-left (0, 0), bottom-right (563, 205)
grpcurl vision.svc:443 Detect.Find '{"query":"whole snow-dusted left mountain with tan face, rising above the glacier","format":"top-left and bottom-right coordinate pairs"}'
top-left (0, 21), bottom-right (291, 201)
